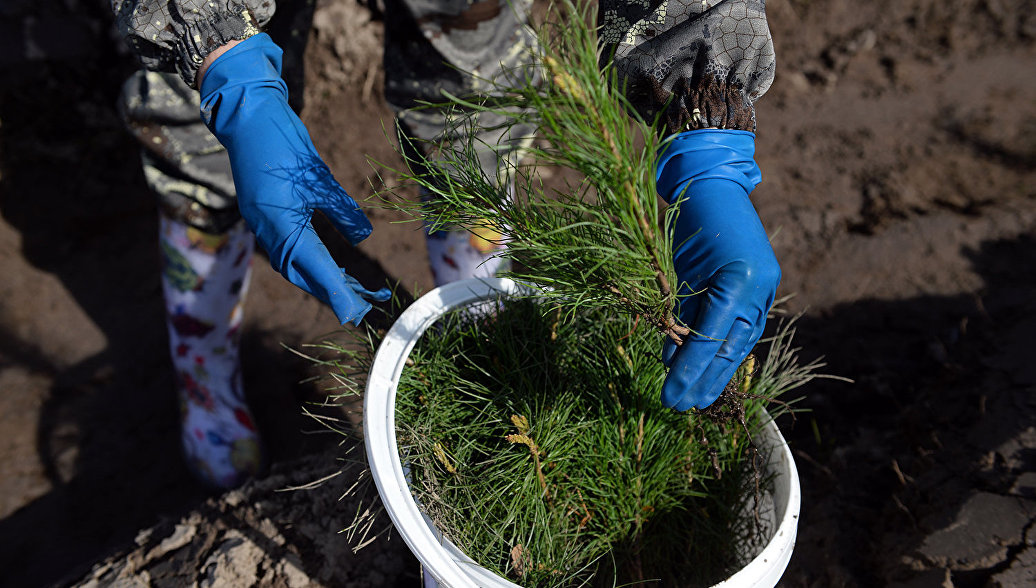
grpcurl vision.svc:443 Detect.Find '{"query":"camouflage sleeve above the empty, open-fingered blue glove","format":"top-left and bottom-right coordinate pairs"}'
top-left (111, 0), bottom-right (275, 86)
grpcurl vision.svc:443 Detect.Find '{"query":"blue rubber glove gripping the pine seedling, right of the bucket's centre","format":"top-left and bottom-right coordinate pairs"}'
top-left (656, 129), bottom-right (780, 411)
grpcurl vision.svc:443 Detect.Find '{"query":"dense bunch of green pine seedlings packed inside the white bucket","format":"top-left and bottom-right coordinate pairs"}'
top-left (396, 297), bottom-right (814, 588)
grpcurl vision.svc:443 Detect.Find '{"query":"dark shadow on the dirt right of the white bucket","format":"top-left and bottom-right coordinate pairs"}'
top-left (781, 235), bottom-right (1036, 586)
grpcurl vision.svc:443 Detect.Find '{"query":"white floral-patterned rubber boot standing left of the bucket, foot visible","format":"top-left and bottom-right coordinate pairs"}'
top-left (160, 215), bottom-right (265, 489)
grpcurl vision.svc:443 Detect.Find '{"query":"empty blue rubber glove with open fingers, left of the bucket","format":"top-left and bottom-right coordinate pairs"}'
top-left (201, 33), bottom-right (391, 325)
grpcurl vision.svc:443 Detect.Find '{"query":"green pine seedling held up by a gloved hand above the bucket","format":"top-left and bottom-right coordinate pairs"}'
top-left (391, 0), bottom-right (689, 341)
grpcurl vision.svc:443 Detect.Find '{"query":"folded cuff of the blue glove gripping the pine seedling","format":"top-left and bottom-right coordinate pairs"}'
top-left (655, 128), bottom-right (762, 204)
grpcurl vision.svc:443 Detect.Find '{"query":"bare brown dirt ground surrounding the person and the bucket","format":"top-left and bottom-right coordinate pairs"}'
top-left (0, 0), bottom-right (1036, 587)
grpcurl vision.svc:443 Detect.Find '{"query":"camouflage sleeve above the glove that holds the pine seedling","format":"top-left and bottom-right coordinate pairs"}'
top-left (599, 0), bottom-right (775, 133)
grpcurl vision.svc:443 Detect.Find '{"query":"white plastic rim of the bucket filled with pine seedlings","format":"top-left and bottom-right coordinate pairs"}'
top-left (364, 278), bottom-right (801, 588)
